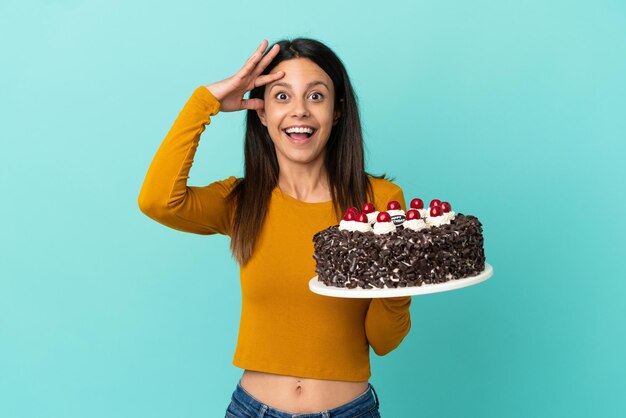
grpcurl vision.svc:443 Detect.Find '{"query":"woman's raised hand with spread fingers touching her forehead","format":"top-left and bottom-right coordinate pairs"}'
top-left (206, 39), bottom-right (285, 112)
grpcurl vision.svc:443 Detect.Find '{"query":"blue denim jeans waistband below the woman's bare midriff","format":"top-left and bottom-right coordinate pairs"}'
top-left (226, 380), bottom-right (380, 418)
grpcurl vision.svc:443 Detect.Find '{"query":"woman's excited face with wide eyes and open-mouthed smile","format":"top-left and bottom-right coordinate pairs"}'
top-left (258, 58), bottom-right (339, 167)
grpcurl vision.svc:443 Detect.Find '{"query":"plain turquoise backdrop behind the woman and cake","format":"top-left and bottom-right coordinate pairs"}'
top-left (0, 0), bottom-right (626, 418)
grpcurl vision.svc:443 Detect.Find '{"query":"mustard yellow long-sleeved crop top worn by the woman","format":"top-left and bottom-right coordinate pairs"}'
top-left (139, 86), bottom-right (411, 381)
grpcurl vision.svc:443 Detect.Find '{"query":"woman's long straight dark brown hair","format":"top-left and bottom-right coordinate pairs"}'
top-left (229, 38), bottom-right (384, 265)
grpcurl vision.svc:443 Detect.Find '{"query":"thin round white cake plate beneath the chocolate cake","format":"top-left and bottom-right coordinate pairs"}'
top-left (309, 263), bottom-right (493, 298)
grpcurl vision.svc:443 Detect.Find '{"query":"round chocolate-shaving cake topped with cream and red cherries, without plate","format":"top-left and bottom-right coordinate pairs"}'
top-left (313, 198), bottom-right (485, 289)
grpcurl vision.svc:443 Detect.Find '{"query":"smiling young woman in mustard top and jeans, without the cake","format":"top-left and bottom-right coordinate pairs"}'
top-left (139, 38), bottom-right (411, 418)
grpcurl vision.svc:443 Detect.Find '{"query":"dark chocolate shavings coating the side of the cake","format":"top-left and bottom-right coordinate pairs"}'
top-left (313, 214), bottom-right (485, 289)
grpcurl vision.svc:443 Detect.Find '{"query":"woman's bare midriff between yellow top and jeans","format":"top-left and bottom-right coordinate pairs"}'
top-left (241, 370), bottom-right (368, 414)
